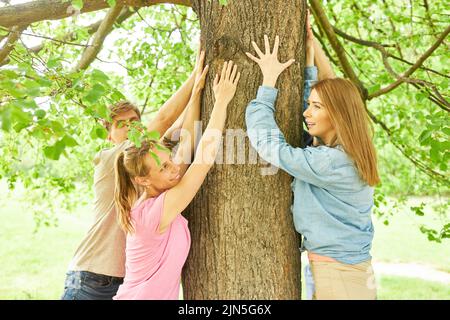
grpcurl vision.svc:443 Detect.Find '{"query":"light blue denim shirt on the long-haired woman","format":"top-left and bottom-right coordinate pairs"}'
top-left (245, 67), bottom-right (374, 264)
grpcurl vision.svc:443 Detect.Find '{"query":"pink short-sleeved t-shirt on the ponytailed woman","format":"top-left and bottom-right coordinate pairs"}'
top-left (113, 192), bottom-right (191, 300)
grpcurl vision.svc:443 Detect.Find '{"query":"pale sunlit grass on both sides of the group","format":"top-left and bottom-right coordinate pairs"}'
top-left (0, 194), bottom-right (450, 299)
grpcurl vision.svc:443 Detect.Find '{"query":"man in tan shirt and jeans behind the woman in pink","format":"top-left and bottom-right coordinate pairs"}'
top-left (61, 58), bottom-right (203, 300)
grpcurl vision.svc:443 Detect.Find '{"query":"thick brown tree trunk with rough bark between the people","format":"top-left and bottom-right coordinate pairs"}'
top-left (183, 0), bottom-right (306, 299)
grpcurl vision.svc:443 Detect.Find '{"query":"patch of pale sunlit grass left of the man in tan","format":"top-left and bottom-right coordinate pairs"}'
top-left (0, 201), bottom-right (90, 300)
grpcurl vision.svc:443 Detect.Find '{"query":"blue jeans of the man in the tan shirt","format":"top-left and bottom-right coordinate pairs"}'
top-left (61, 271), bottom-right (123, 300)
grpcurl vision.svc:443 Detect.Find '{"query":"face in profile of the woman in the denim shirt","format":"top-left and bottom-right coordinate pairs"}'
top-left (303, 89), bottom-right (336, 145)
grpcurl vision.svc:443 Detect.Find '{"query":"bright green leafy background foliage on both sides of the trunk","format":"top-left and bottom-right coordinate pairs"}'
top-left (0, 0), bottom-right (450, 241)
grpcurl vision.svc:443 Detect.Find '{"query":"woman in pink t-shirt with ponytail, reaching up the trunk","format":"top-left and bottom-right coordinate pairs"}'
top-left (113, 57), bottom-right (240, 300)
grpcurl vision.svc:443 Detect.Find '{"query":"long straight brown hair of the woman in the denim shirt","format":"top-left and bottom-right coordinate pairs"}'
top-left (312, 78), bottom-right (380, 186)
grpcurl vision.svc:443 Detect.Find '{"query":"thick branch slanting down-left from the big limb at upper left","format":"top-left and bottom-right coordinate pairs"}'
top-left (75, 3), bottom-right (123, 71)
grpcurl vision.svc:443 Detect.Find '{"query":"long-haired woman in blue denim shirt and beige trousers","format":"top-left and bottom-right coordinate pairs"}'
top-left (246, 11), bottom-right (379, 299)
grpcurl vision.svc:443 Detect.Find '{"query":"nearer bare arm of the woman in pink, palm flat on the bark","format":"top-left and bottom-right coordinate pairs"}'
top-left (159, 62), bottom-right (240, 233)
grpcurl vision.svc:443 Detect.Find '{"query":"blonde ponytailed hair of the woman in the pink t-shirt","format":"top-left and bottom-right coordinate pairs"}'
top-left (114, 140), bottom-right (156, 233)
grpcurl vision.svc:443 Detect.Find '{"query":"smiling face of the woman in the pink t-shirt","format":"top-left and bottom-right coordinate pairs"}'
top-left (135, 148), bottom-right (181, 195)
